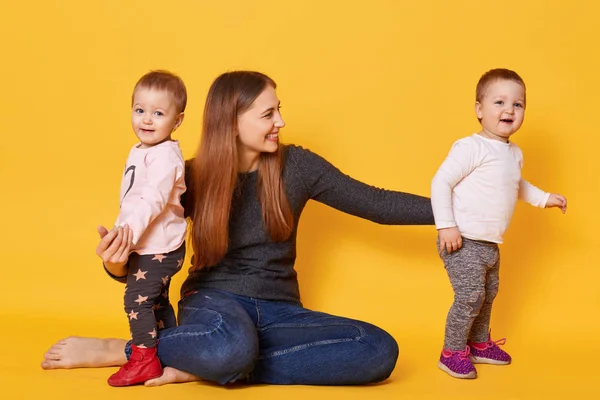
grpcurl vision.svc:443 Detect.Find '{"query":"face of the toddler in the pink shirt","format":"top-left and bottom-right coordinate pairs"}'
top-left (131, 89), bottom-right (183, 148)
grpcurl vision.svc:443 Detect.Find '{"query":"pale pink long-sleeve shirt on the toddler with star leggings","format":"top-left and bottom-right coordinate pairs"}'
top-left (116, 141), bottom-right (187, 254)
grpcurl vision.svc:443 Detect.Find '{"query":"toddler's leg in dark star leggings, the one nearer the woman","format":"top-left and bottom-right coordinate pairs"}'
top-left (149, 243), bottom-right (185, 330)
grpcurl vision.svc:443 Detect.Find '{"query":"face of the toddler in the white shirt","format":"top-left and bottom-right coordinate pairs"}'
top-left (475, 80), bottom-right (525, 142)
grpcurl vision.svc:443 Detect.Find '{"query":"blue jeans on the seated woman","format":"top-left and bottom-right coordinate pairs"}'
top-left (126, 289), bottom-right (398, 385)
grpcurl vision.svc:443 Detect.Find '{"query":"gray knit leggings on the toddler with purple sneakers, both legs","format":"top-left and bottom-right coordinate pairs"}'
top-left (438, 238), bottom-right (500, 351)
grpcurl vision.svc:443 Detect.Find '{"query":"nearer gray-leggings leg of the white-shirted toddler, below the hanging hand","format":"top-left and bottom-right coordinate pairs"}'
top-left (440, 239), bottom-right (493, 351)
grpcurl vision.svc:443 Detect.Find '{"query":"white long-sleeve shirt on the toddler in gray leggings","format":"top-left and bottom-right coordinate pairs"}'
top-left (431, 134), bottom-right (550, 243)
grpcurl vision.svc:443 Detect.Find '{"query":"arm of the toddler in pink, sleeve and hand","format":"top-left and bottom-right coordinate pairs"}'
top-left (117, 148), bottom-right (183, 245)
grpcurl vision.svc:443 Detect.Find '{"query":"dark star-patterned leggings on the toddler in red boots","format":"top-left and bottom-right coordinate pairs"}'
top-left (125, 243), bottom-right (185, 348)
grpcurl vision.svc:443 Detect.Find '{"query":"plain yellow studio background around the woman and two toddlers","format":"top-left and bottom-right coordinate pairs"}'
top-left (0, 0), bottom-right (600, 399)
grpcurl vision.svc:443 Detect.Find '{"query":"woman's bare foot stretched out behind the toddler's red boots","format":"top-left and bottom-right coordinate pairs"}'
top-left (42, 336), bottom-right (128, 370)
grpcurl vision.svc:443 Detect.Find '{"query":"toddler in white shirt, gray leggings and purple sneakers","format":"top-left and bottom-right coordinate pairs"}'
top-left (431, 69), bottom-right (567, 378)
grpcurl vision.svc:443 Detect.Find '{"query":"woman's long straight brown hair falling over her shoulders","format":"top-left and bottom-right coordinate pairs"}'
top-left (187, 71), bottom-right (294, 270)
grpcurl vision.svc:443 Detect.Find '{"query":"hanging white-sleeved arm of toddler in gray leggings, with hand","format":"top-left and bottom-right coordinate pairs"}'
top-left (431, 138), bottom-right (479, 253)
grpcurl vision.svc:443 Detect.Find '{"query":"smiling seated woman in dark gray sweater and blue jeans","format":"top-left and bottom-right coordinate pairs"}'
top-left (42, 71), bottom-right (434, 386)
